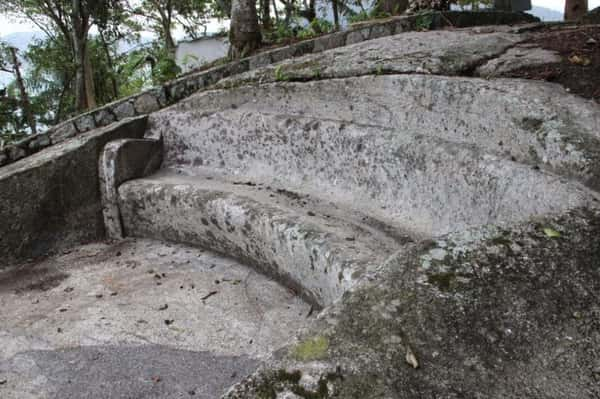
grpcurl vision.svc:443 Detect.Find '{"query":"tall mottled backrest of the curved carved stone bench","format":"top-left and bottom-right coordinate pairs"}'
top-left (143, 75), bottom-right (600, 237)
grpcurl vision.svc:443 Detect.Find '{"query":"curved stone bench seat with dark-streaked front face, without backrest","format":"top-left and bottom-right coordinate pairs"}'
top-left (119, 170), bottom-right (413, 306)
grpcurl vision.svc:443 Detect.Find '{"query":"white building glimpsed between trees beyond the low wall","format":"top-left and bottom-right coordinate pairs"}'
top-left (175, 35), bottom-right (229, 73)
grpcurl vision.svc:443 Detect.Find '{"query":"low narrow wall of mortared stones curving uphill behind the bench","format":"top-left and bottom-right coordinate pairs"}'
top-left (0, 11), bottom-right (538, 167)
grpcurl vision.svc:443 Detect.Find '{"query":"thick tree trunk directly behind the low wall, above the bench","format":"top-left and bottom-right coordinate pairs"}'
top-left (229, 0), bottom-right (261, 59)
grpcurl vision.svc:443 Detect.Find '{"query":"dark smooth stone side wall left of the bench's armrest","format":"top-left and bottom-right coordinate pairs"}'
top-left (0, 116), bottom-right (146, 269)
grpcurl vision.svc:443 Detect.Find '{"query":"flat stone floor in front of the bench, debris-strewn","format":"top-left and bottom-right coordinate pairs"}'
top-left (0, 240), bottom-right (311, 399)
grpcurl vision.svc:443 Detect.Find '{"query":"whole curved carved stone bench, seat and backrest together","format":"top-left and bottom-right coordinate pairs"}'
top-left (103, 76), bottom-right (597, 306)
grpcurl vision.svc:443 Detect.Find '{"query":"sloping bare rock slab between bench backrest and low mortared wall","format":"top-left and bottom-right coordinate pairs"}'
top-left (218, 30), bottom-right (523, 87)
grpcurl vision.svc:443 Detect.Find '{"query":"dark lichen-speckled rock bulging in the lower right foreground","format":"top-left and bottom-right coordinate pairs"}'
top-left (226, 209), bottom-right (600, 399)
